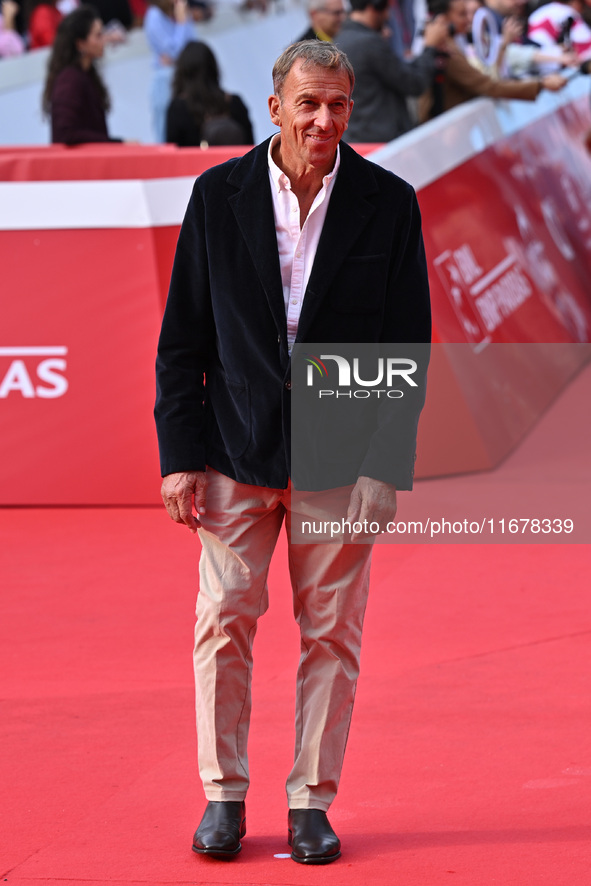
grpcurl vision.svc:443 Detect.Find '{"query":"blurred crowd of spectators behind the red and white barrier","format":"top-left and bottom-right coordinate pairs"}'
top-left (0, 0), bottom-right (591, 146)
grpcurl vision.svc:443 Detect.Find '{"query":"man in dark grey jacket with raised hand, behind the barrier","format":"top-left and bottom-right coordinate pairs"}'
top-left (337, 0), bottom-right (447, 142)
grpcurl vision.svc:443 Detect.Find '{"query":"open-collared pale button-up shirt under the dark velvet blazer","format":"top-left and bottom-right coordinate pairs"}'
top-left (268, 135), bottom-right (340, 354)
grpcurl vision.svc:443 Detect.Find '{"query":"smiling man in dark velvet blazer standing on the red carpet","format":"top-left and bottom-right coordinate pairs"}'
top-left (155, 41), bottom-right (430, 864)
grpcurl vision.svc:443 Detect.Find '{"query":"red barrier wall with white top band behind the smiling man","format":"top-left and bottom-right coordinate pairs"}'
top-left (0, 78), bottom-right (591, 505)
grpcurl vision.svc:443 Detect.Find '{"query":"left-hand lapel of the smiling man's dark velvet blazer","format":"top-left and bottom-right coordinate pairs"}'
top-left (228, 140), bottom-right (287, 336)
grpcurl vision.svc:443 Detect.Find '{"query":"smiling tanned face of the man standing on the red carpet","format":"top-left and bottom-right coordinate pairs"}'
top-left (269, 59), bottom-right (353, 171)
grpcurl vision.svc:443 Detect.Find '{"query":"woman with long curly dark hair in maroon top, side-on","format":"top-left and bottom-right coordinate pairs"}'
top-left (43, 6), bottom-right (121, 145)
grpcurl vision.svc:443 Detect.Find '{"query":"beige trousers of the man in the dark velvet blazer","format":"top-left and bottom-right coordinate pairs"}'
top-left (194, 469), bottom-right (371, 811)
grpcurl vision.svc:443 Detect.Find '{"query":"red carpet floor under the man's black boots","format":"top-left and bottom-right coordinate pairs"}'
top-left (0, 370), bottom-right (591, 886)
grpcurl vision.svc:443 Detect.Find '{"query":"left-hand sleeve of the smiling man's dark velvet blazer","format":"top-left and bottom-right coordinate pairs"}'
top-left (154, 183), bottom-right (215, 476)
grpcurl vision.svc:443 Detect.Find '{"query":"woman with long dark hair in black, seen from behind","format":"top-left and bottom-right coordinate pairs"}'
top-left (166, 41), bottom-right (254, 147)
